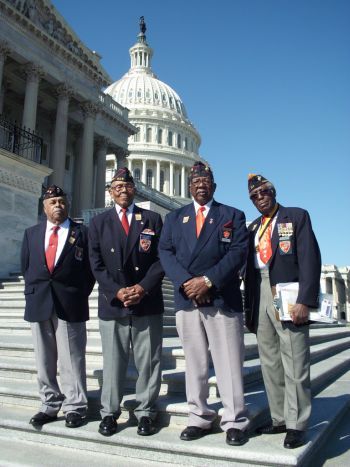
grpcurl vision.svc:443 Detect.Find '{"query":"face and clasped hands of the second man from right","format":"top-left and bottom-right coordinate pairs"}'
top-left (182, 177), bottom-right (216, 305)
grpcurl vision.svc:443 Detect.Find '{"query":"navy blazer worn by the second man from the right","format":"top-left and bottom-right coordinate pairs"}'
top-left (159, 201), bottom-right (248, 312)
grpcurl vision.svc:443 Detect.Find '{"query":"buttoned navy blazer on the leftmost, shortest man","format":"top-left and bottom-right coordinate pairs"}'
top-left (21, 220), bottom-right (95, 322)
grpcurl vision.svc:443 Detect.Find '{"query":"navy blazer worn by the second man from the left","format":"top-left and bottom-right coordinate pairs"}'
top-left (89, 206), bottom-right (164, 320)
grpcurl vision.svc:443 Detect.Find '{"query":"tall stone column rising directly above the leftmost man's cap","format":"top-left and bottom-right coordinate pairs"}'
top-left (50, 84), bottom-right (72, 188)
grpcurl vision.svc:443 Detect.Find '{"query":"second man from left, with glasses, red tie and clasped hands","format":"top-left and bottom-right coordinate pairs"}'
top-left (89, 167), bottom-right (164, 436)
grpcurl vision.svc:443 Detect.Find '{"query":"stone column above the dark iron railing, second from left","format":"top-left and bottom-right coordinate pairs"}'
top-left (22, 64), bottom-right (43, 131)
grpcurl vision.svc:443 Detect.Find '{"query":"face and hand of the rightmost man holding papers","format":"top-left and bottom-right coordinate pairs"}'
top-left (249, 183), bottom-right (309, 324)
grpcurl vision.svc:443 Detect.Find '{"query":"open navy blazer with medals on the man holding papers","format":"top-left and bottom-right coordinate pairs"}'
top-left (244, 205), bottom-right (321, 332)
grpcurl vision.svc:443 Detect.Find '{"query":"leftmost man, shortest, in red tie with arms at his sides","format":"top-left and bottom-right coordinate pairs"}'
top-left (21, 185), bottom-right (95, 428)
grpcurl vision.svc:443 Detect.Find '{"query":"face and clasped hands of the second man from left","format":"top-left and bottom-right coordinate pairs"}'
top-left (109, 181), bottom-right (146, 307)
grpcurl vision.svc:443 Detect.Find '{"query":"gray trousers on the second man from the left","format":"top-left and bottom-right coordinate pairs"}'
top-left (100, 314), bottom-right (163, 420)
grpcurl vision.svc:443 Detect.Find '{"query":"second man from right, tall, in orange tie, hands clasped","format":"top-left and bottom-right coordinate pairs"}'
top-left (159, 162), bottom-right (249, 445)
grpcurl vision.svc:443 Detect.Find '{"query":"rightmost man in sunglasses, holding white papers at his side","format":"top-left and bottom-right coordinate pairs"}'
top-left (245, 174), bottom-right (321, 449)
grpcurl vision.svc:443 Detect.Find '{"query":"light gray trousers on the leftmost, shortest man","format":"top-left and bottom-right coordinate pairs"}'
top-left (31, 313), bottom-right (87, 416)
